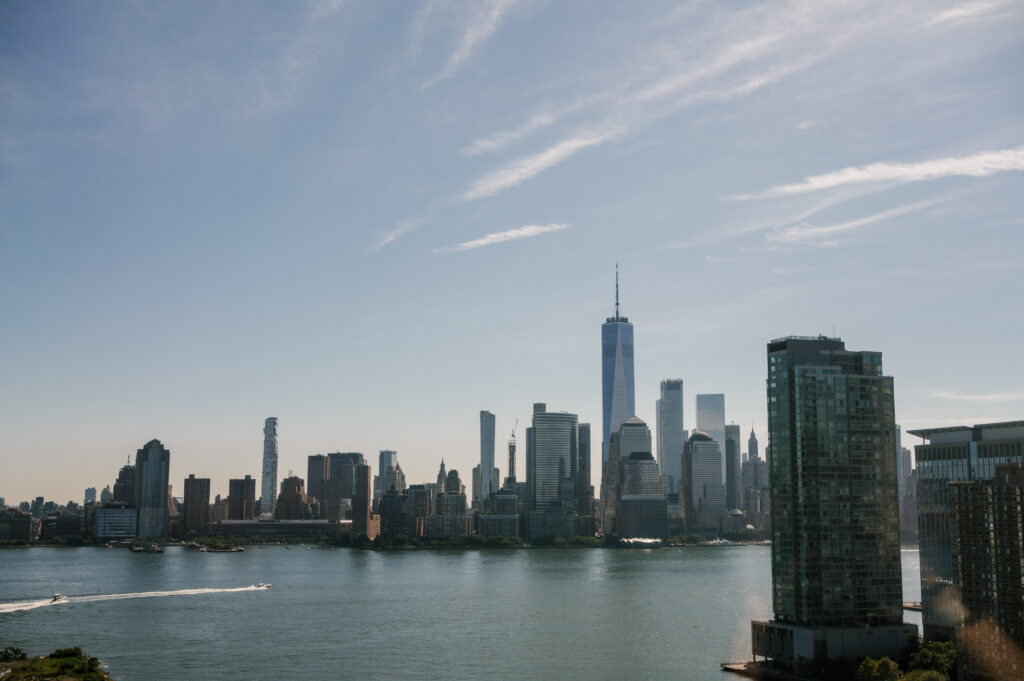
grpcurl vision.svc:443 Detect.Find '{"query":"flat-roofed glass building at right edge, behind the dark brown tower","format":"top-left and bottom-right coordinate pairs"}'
top-left (908, 421), bottom-right (1024, 641)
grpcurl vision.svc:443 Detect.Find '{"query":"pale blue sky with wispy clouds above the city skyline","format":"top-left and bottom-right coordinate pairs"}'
top-left (0, 0), bottom-right (1024, 503)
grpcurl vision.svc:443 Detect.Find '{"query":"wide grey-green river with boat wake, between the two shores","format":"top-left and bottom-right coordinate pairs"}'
top-left (0, 546), bottom-right (921, 681)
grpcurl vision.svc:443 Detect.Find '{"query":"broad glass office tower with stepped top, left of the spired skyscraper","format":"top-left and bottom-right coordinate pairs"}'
top-left (526, 402), bottom-right (580, 513)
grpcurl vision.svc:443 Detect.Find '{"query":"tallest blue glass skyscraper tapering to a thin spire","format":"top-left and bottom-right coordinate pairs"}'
top-left (601, 265), bottom-right (636, 462)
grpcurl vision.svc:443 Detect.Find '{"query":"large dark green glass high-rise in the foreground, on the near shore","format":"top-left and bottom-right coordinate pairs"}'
top-left (752, 336), bottom-right (916, 672)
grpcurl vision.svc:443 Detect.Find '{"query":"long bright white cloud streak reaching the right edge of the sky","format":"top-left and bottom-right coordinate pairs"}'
top-left (732, 146), bottom-right (1024, 200)
